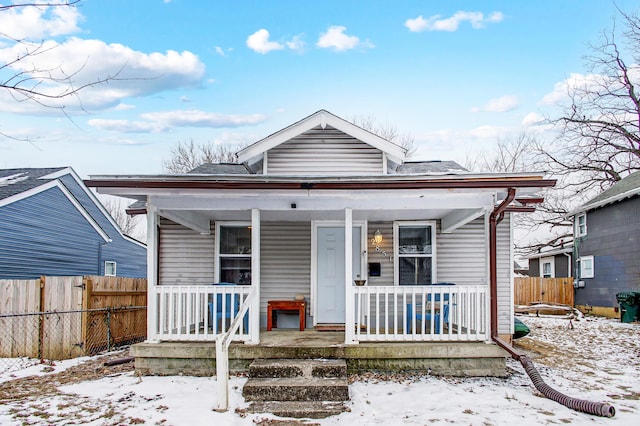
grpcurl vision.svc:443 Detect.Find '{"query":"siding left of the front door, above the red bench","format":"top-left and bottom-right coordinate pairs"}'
top-left (260, 222), bottom-right (311, 326)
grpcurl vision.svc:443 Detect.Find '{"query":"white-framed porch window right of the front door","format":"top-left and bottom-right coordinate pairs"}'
top-left (393, 222), bottom-right (436, 285)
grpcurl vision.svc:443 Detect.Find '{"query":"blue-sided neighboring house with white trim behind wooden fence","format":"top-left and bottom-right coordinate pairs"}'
top-left (0, 167), bottom-right (147, 279)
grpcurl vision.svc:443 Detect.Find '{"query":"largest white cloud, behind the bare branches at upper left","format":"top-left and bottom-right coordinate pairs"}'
top-left (0, 37), bottom-right (205, 112)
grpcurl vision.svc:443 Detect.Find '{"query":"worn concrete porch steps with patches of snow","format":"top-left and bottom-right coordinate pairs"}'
top-left (242, 359), bottom-right (349, 418)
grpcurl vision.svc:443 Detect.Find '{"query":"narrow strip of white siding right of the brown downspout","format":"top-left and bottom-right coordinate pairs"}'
top-left (497, 213), bottom-right (513, 334)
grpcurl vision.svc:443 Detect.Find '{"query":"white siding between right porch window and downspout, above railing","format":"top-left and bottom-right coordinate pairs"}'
top-left (436, 217), bottom-right (488, 285)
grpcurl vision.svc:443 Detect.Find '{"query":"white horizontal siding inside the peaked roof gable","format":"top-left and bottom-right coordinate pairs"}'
top-left (265, 126), bottom-right (383, 176)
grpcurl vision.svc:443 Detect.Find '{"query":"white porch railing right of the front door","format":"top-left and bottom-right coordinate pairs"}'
top-left (347, 285), bottom-right (488, 342)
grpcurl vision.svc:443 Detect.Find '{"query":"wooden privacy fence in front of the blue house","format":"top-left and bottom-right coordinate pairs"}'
top-left (0, 276), bottom-right (147, 359)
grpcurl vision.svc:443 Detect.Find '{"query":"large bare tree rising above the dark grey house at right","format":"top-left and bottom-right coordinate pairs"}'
top-left (468, 11), bottom-right (640, 254)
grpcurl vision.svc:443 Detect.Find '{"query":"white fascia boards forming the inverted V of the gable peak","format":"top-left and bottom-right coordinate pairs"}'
top-left (238, 110), bottom-right (406, 163)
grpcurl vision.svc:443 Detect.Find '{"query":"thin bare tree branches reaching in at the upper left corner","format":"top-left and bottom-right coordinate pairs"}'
top-left (0, 0), bottom-right (118, 139)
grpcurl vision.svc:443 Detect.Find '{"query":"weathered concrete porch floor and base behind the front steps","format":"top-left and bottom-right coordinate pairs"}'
top-left (131, 329), bottom-right (507, 376)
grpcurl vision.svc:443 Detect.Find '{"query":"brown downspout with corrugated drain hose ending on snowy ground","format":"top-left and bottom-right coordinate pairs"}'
top-left (489, 188), bottom-right (616, 417)
